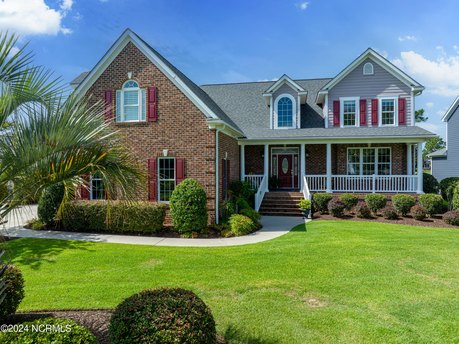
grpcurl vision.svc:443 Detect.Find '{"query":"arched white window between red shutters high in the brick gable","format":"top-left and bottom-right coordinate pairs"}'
top-left (116, 80), bottom-right (146, 122)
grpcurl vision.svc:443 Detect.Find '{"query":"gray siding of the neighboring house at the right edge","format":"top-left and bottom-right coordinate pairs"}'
top-left (432, 108), bottom-right (459, 181)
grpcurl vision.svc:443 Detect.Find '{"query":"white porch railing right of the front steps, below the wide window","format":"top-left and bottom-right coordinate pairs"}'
top-left (305, 175), bottom-right (418, 192)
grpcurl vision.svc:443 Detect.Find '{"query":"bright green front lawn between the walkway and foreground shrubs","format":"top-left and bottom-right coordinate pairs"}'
top-left (2, 221), bottom-right (459, 343)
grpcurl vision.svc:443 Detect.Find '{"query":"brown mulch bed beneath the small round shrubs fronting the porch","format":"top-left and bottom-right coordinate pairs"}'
top-left (313, 212), bottom-right (459, 229)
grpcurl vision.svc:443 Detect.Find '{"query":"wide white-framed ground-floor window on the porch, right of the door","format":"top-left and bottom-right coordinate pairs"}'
top-left (347, 147), bottom-right (391, 176)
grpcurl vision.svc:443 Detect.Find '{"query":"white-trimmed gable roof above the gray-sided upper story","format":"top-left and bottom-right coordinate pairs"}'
top-left (316, 48), bottom-right (424, 104)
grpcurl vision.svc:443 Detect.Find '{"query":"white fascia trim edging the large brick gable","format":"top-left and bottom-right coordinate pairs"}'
top-left (74, 29), bottom-right (218, 119)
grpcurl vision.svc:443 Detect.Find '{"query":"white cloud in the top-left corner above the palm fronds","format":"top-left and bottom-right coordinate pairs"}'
top-left (0, 0), bottom-right (73, 35)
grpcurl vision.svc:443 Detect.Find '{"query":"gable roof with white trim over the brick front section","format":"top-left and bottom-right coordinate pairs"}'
top-left (73, 29), bottom-right (242, 134)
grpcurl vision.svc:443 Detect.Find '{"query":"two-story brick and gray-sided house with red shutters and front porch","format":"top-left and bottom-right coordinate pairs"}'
top-left (72, 29), bottom-right (433, 221)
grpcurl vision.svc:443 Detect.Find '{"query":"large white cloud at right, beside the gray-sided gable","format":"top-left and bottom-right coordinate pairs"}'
top-left (392, 46), bottom-right (459, 97)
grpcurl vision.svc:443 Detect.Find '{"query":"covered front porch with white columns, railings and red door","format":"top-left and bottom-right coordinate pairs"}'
top-left (240, 141), bottom-right (423, 208)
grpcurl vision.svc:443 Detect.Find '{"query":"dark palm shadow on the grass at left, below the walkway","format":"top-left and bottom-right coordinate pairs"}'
top-left (0, 237), bottom-right (94, 270)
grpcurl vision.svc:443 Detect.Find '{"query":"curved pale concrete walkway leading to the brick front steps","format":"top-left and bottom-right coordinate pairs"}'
top-left (1, 207), bottom-right (304, 247)
